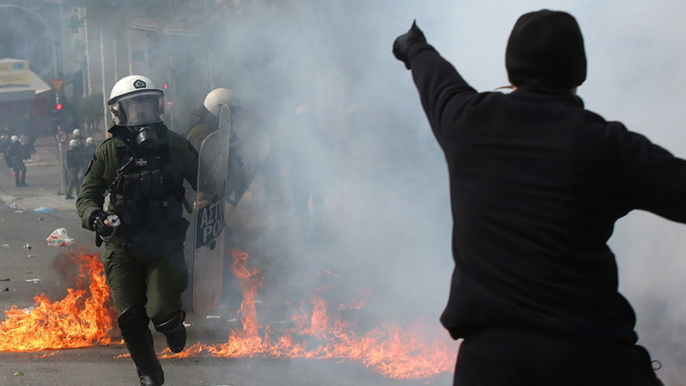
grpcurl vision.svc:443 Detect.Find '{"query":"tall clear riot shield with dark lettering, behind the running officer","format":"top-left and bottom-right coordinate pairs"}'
top-left (192, 105), bottom-right (231, 314)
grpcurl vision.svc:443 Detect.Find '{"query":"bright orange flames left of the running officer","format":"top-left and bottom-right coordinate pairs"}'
top-left (0, 254), bottom-right (116, 351)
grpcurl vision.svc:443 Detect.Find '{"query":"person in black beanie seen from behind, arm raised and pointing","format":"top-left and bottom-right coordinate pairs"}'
top-left (393, 10), bottom-right (672, 386)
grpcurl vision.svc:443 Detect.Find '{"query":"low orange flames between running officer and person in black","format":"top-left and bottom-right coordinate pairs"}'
top-left (162, 250), bottom-right (456, 379)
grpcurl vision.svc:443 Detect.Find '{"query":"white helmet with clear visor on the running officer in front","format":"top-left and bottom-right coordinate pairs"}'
top-left (107, 75), bottom-right (164, 126)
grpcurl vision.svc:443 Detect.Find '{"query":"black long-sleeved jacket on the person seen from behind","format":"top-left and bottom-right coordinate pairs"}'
top-left (408, 43), bottom-right (686, 345)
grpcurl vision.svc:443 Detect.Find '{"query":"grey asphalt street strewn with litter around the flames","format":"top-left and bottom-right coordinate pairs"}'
top-left (0, 133), bottom-right (451, 386)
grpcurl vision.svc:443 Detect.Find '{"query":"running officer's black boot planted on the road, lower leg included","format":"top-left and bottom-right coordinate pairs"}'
top-left (118, 306), bottom-right (164, 386)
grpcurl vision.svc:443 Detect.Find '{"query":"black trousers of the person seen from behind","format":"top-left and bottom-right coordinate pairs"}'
top-left (453, 329), bottom-right (662, 386)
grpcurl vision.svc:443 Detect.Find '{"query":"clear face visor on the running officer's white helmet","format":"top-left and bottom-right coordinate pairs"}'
top-left (116, 90), bottom-right (164, 126)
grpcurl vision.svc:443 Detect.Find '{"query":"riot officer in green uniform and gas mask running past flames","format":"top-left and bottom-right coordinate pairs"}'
top-left (76, 75), bottom-right (198, 386)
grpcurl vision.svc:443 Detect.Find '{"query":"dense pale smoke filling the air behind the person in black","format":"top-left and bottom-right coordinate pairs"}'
top-left (196, 0), bottom-right (686, 362)
